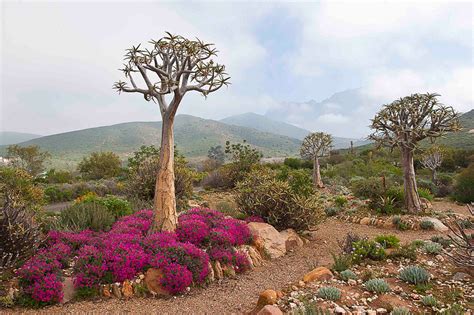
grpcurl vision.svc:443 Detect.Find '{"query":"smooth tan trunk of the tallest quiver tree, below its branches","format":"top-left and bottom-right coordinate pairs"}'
top-left (151, 115), bottom-right (178, 232)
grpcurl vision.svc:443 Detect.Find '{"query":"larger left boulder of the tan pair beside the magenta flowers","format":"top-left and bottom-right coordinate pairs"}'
top-left (248, 222), bottom-right (286, 259)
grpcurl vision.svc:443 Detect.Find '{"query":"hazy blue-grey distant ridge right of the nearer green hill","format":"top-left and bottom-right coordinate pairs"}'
top-left (220, 113), bottom-right (369, 149)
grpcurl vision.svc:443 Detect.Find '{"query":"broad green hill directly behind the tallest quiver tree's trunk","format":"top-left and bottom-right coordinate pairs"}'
top-left (1, 115), bottom-right (301, 167)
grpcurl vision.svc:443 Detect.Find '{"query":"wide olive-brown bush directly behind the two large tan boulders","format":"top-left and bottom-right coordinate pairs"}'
top-left (236, 167), bottom-right (323, 230)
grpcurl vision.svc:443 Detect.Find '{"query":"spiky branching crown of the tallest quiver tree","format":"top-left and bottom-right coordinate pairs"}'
top-left (114, 33), bottom-right (230, 116)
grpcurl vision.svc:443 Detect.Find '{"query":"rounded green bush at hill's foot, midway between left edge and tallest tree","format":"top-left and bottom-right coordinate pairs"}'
top-left (78, 152), bottom-right (122, 179)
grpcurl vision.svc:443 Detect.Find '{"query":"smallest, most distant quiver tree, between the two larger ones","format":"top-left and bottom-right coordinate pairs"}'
top-left (300, 132), bottom-right (332, 188)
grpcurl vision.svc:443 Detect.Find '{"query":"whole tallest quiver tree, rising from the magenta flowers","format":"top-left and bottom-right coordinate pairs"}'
top-left (114, 33), bottom-right (229, 232)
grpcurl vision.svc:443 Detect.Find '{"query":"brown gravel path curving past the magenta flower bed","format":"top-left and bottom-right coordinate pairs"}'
top-left (8, 219), bottom-right (439, 314)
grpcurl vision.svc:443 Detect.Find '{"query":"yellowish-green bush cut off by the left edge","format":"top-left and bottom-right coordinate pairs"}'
top-left (0, 166), bottom-right (44, 210)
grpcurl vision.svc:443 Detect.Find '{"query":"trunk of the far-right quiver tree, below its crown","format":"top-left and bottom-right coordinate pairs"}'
top-left (401, 148), bottom-right (421, 212)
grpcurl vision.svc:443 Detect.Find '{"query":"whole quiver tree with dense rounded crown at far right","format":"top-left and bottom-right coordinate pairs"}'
top-left (369, 93), bottom-right (459, 212)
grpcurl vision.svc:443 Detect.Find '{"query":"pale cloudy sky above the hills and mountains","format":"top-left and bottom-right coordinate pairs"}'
top-left (0, 0), bottom-right (474, 137)
